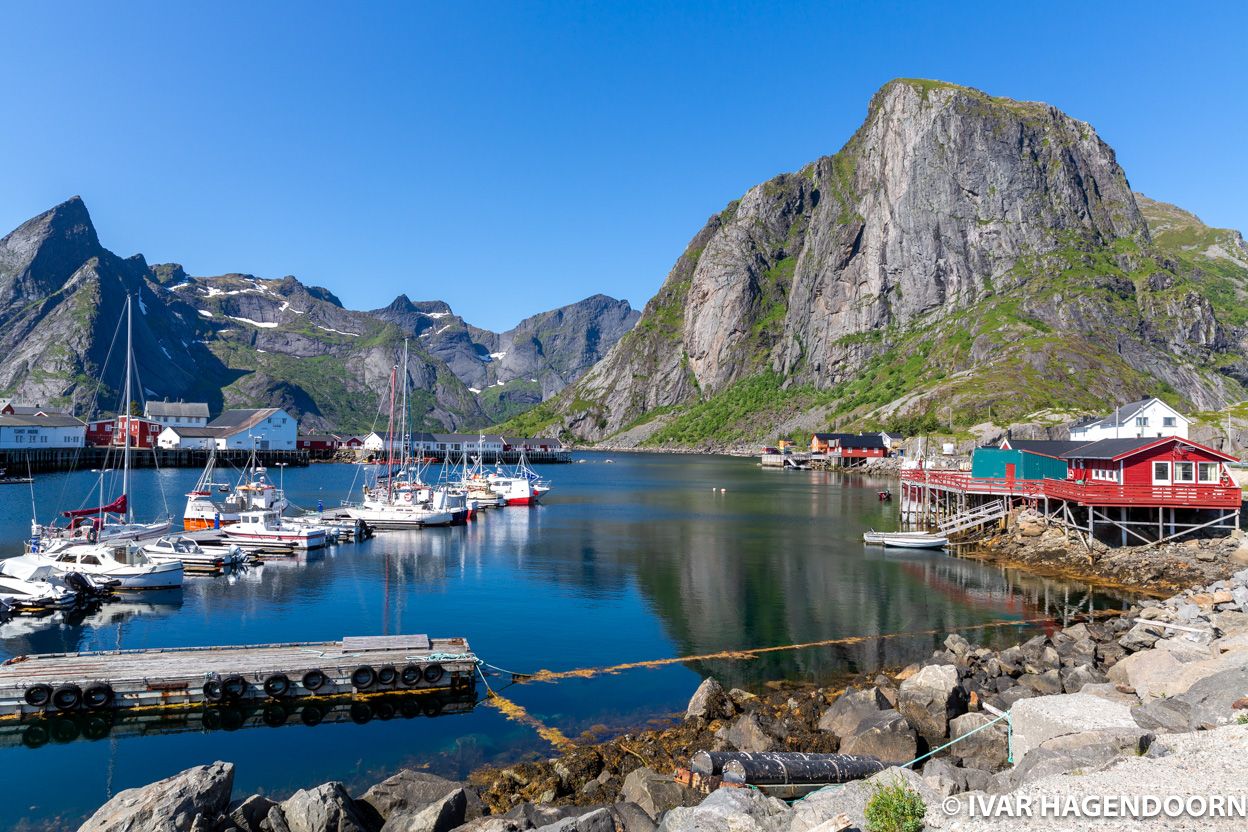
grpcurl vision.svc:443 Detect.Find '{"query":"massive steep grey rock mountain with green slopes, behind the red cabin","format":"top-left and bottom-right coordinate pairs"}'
top-left (508, 80), bottom-right (1248, 447)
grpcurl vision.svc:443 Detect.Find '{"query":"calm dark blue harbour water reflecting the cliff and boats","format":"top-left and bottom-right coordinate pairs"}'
top-left (0, 454), bottom-right (1121, 828)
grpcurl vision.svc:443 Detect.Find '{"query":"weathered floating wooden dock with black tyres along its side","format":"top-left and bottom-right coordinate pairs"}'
top-left (0, 635), bottom-right (477, 718)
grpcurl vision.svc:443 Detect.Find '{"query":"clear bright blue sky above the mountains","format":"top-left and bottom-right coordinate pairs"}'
top-left (0, 1), bottom-right (1248, 328)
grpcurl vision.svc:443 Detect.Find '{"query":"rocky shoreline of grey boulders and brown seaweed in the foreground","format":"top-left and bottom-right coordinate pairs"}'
top-left (73, 515), bottom-right (1248, 832)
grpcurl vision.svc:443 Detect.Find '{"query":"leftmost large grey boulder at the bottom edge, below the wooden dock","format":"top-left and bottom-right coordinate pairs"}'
top-left (79, 761), bottom-right (233, 832)
